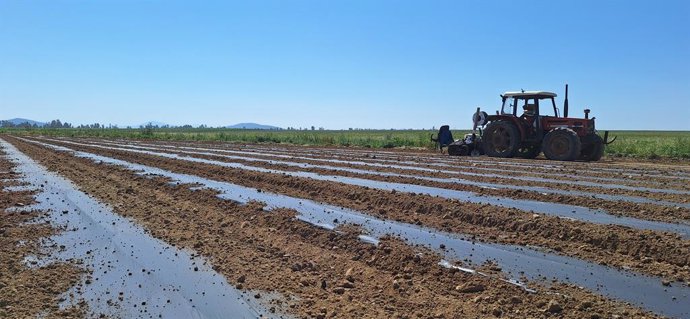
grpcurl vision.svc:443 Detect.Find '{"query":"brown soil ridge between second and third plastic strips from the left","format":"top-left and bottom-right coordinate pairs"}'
top-left (13, 136), bottom-right (690, 281)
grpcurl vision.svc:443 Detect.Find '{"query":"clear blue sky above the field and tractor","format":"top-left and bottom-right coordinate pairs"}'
top-left (0, 0), bottom-right (690, 130)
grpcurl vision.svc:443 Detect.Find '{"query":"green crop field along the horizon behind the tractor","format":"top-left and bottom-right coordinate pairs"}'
top-left (0, 128), bottom-right (690, 159)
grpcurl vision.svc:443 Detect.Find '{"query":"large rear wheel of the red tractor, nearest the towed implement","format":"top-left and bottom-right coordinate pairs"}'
top-left (482, 121), bottom-right (521, 157)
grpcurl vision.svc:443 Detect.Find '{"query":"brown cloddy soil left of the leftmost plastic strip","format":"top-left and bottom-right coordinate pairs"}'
top-left (0, 152), bottom-right (85, 318)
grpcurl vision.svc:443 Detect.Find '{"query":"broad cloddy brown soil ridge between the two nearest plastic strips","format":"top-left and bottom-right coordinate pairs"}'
top-left (1, 136), bottom-right (668, 318)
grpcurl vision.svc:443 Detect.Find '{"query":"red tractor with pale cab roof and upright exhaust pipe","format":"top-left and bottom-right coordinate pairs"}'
top-left (473, 84), bottom-right (615, 161)
